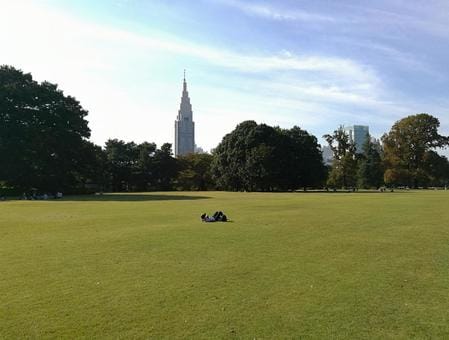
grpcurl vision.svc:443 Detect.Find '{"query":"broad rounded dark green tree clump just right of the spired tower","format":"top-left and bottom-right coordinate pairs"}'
top-left (212, 121), bottom-right (325, 191)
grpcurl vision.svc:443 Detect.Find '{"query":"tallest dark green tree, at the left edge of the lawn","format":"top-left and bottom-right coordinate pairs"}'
top-left (0, 66), bottom-right (90, 192)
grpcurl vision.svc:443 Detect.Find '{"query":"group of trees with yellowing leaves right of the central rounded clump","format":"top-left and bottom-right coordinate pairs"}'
top-left (324, 113), bottom-right (449, 189)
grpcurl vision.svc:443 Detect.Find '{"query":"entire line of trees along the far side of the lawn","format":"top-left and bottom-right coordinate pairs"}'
top-left (0, 66), bottom-right (449, 193)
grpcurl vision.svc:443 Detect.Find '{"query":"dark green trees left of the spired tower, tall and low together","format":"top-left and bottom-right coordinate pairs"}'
top-left (0, 66), bottom-right (184, 193)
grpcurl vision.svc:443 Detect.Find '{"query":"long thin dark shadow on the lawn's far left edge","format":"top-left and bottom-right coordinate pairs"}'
top-left (58, 194), bottom-right (210, 202)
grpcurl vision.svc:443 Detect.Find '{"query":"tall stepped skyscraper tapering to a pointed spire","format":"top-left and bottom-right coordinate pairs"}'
top-left (175, 71), bottom-right (195, 157)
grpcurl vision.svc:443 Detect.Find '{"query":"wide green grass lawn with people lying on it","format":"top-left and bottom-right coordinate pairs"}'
top-left (0, 191), bottom-right (449, 339)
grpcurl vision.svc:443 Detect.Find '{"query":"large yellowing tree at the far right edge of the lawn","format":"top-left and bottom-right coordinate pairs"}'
top-left (382, 113), bottom-right (449, 187)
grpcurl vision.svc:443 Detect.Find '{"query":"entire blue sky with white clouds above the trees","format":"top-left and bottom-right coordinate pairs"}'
top-left (0, 0), bottom-right (449, 154)
